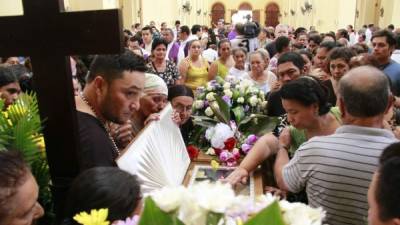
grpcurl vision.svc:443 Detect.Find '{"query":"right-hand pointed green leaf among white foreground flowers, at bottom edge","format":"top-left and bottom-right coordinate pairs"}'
top-left (244, 201), bottom-right (285, 225)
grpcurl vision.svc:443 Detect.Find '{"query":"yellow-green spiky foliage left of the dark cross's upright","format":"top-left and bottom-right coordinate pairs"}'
top-left (0, 94), bottom-right (54, 224)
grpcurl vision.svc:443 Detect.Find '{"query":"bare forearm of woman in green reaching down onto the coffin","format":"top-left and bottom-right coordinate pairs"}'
top-left (225, 133), bottom-right (278, 185)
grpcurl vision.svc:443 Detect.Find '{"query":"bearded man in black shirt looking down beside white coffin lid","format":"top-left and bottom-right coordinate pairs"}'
top-left (75, 51), bottom-right (146, 171)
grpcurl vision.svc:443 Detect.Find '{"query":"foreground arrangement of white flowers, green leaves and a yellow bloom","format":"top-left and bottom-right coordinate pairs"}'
top-left (73, 181), bottom-right (325, 225)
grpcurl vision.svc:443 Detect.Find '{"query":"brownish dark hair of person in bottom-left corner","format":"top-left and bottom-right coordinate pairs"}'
top-left (0, 150), bottom-right (30, 224)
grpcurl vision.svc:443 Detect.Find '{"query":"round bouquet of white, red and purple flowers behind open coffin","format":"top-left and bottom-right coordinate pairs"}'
top-left (190, 76), bottom-right (278, 166)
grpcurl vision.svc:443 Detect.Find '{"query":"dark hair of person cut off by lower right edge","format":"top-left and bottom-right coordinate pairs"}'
top-left (373, 143), bottom-right (400, 221)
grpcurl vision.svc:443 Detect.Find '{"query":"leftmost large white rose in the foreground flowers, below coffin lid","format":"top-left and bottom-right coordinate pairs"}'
top-left (150, 186), bottom-right (186, 213)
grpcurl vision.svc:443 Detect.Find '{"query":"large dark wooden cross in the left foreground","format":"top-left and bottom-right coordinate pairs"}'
top-left (0, 0), bottom-right (123, 218)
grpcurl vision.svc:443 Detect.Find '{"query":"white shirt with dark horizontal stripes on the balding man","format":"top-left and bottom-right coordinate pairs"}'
top-left (283, 125), bottom-right (398, 225)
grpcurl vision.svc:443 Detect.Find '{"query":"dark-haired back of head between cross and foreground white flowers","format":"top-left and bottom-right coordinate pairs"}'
top-left (65, 167), bottom-right (141, 224)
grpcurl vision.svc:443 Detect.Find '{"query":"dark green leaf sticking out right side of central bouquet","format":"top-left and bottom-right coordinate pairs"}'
top-left (239, 115), bottom-right (279, 136)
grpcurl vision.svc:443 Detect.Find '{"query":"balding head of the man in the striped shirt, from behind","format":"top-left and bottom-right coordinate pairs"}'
top-left (339, 66), bottom-right (390, 118)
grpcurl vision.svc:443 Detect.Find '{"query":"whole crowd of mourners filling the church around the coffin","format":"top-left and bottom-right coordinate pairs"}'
top-left (0, 21), bottom-right (400, 225)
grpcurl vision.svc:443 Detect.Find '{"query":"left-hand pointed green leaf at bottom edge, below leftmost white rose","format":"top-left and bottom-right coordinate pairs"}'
top-left (139, 197), bottom-right (184, 225)
